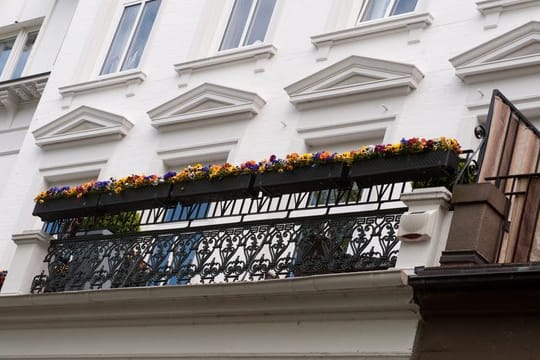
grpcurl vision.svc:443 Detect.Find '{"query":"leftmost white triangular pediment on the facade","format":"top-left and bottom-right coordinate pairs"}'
top-left (32, 106), bottom-right (133, 148)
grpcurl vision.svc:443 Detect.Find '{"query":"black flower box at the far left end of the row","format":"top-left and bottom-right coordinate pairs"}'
top-left (32, 194), bottom-right (100, 221)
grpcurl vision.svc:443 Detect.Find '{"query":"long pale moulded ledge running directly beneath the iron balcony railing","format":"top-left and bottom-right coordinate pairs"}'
top-left (0, 270), bottom-right (417, 329)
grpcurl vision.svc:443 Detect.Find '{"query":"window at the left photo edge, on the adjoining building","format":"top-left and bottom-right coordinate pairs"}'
top-left (0, 30), bottom-right (38, 80)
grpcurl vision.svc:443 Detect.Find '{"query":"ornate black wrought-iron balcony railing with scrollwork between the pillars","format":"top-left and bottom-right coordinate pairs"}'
top-left (32, 183), bottom-right (408, 293)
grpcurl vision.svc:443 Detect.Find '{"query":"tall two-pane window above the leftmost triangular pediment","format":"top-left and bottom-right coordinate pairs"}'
top-left (100, 0), bottom-right (161, 75)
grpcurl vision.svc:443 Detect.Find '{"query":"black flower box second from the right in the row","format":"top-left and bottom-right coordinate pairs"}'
top-left (254, 163), bottom-right (351, 196)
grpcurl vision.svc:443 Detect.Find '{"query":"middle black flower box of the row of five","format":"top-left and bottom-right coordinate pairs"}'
top-left (171, 174), bottom-right (256, 205)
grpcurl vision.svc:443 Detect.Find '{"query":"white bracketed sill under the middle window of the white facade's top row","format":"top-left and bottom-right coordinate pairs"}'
top-left (174, 44), bottom-right (277, 87)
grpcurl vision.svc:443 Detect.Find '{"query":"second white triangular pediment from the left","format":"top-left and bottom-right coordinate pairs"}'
top-left (148, 83), bottom-right (266, 129)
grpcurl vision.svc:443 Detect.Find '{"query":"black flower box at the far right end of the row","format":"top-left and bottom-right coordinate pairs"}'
top-left (349, 151), bottom-right (459, 187)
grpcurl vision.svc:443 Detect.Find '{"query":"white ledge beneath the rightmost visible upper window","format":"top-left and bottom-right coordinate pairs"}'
top-left (311, 13), bottom-right (433, 48)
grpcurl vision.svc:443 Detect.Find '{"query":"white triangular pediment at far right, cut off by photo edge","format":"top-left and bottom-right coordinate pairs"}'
top-left (450, 21), bottom-right (540, 83)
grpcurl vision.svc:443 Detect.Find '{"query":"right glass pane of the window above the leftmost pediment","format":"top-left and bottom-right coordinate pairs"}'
top-left (121, 0), bottom-right (161, 70)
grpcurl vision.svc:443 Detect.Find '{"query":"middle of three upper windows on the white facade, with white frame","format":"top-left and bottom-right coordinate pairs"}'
top-left (219, 0), bottom-right (276, 50)
